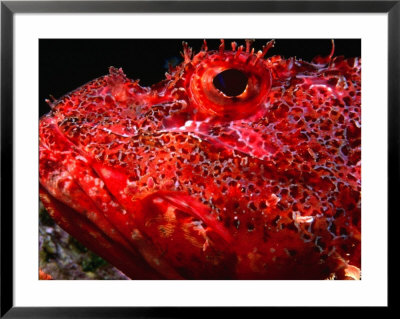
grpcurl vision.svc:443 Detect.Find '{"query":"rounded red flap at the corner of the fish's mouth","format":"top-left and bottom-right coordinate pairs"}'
top-left (133, 191), bottom-right (237, 279)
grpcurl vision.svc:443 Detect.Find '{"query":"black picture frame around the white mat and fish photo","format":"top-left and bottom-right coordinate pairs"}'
top-left (0, 0), bottom-right (394, 318)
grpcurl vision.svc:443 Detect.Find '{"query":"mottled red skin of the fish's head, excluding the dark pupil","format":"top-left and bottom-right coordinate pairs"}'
top-left (39, 42), bottom-right (361, 279)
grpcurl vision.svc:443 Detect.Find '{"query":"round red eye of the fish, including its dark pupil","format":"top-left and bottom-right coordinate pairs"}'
top-left (185, 51), bottom-right (272, 120)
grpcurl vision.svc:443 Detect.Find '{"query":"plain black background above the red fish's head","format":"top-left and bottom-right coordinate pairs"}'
top-left (39, 39), bottom-right (361, 116)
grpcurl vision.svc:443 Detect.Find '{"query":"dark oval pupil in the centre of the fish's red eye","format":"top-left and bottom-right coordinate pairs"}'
top-left (213, 69), bottom-right (247, 96)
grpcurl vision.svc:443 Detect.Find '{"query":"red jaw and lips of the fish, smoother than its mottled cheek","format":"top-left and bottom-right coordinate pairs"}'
top-left (39, 117), bottom-right (235, 279)
